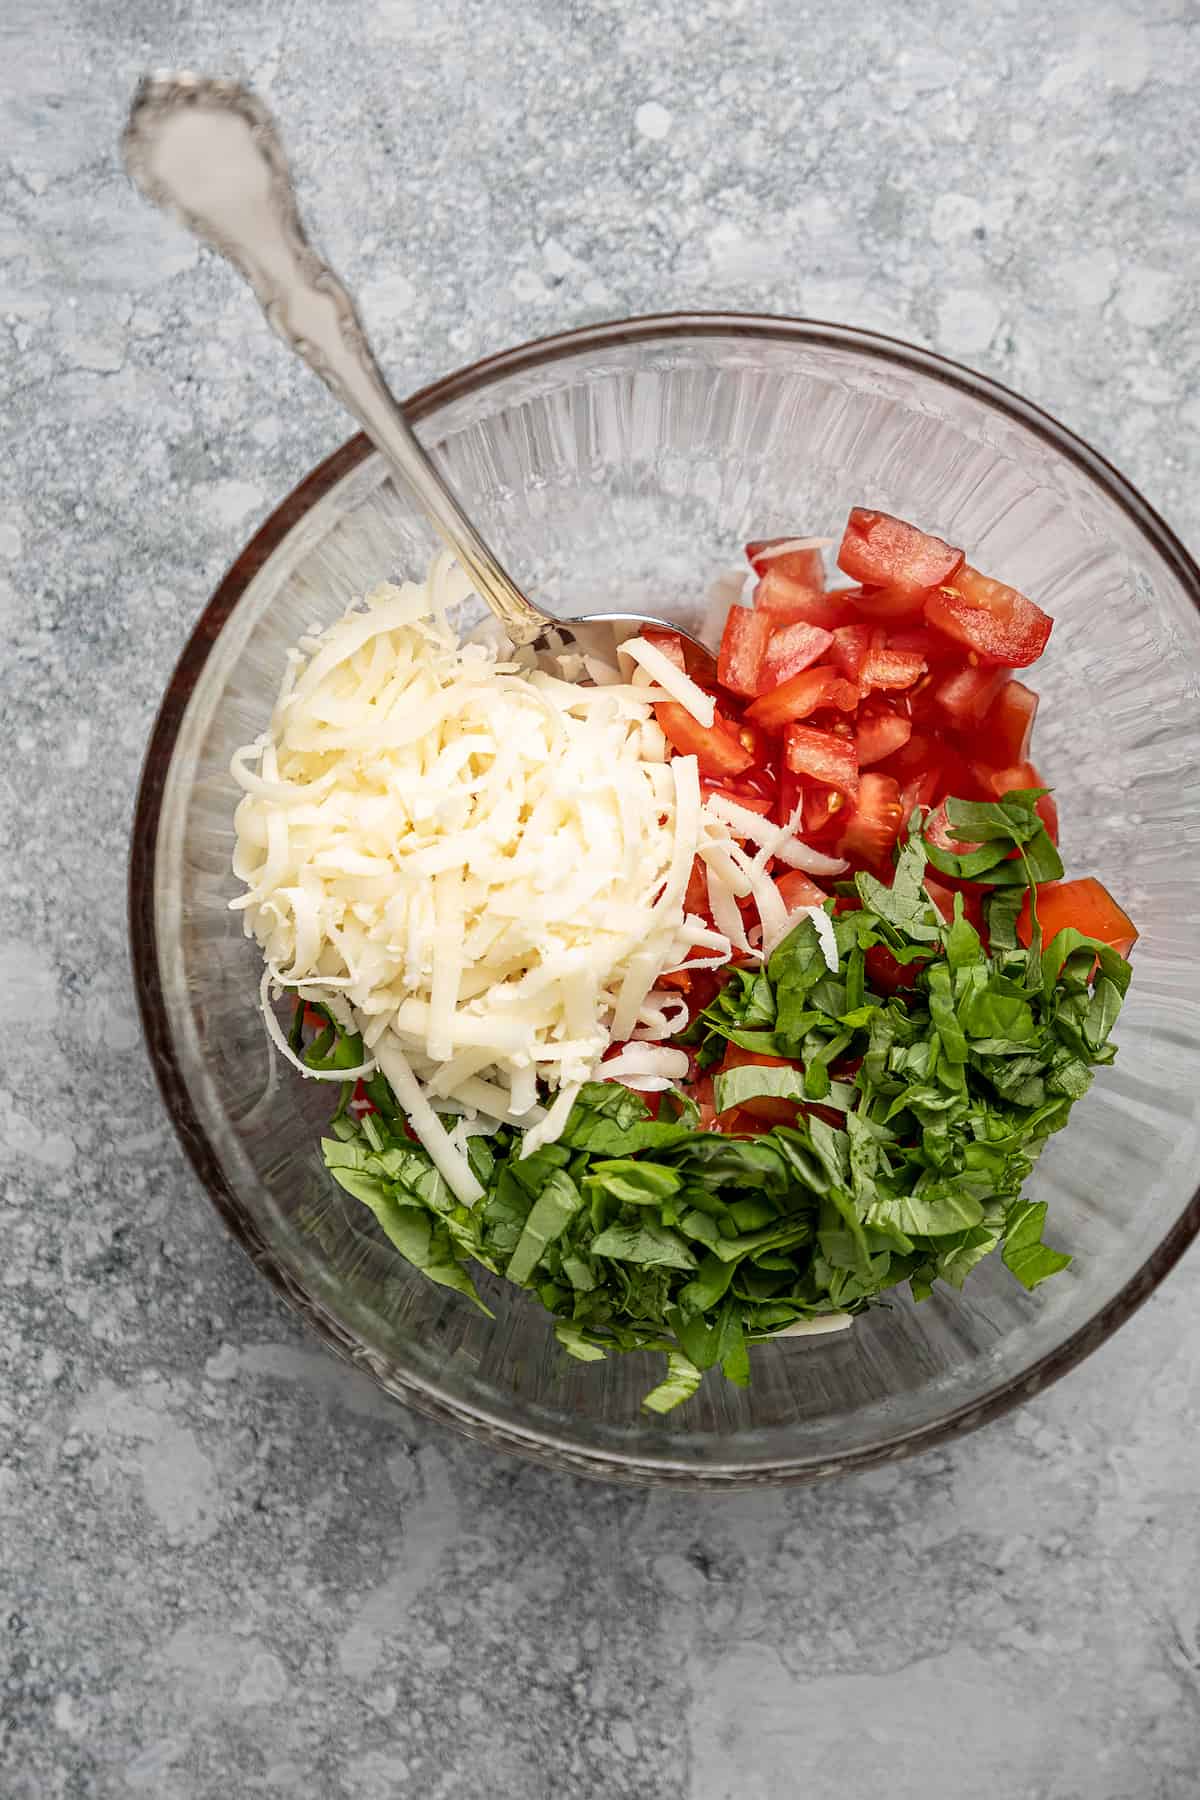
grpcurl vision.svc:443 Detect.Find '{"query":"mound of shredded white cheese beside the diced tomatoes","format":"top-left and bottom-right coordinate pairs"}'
top-left (232, 558), bottom-right (840, 1202)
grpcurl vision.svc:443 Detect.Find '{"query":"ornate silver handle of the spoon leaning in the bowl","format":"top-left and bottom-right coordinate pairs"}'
top-left (122, 74), bottom-right (547, 644)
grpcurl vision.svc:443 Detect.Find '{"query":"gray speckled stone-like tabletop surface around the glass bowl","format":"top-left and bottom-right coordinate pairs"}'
top-left (0, 0), bottom-right (1200, 1800)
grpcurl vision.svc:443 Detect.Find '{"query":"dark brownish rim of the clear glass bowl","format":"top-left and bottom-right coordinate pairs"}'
top-left (128, 311), bottom-right (1200, 1490)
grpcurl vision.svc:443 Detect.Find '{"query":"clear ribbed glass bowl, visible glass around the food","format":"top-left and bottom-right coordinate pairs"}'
top-left (131, 315), bottom-right (1200, 1487)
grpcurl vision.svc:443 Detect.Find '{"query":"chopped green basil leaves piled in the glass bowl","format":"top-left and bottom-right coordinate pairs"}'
top-left (306, 790), bottom-right (1130, 1413)
